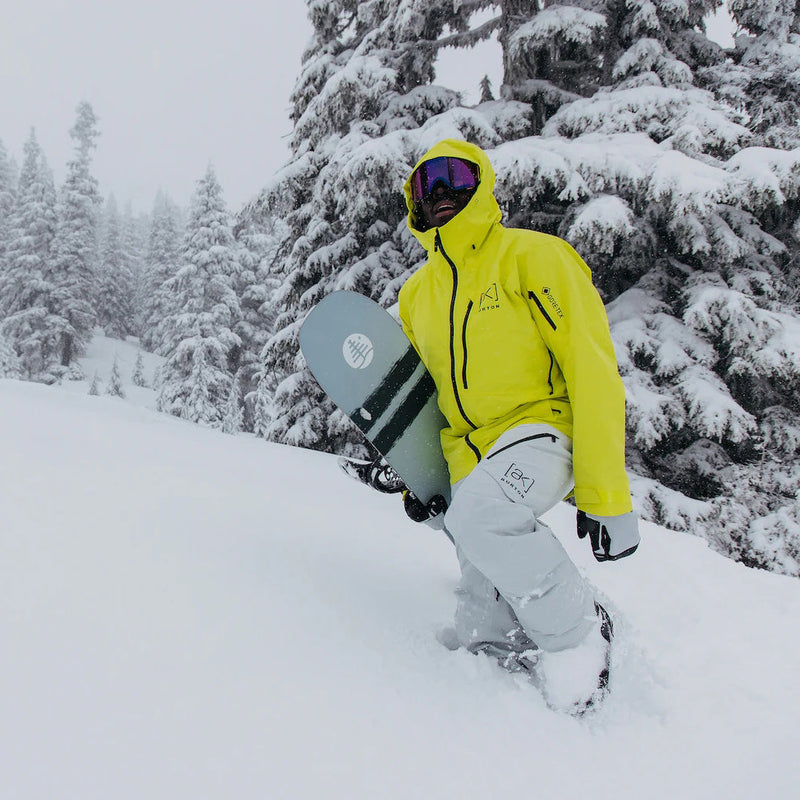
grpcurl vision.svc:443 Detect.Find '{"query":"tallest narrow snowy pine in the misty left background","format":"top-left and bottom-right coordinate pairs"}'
top-left (53, 101), bottom-right (100, 366)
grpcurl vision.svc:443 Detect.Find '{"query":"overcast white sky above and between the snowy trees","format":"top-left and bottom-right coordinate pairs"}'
top-left (0, 0), bottom-right (726, 216)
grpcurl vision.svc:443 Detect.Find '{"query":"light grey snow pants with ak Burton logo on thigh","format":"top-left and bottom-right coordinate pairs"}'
top-left (445, 425), bottom-right (596, 651)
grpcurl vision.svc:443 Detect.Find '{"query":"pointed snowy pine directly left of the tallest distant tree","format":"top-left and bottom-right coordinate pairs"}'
top-left (0, 131), bottom-right (61, 382)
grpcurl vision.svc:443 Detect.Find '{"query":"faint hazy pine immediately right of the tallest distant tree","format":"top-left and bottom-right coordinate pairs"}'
top-left (95, 195), bottom-right (135, 339)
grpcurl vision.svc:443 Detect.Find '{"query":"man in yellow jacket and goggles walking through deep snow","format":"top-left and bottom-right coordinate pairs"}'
top-left (399, 140), bottom-right (639, 710)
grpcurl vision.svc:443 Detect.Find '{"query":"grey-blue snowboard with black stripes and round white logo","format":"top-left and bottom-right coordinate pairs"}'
top-left (300, 291), bottom-right (450, 503)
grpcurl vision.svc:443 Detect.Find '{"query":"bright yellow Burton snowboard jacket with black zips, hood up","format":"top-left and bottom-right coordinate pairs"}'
top-left (399, 139), bottom-right (631, 516)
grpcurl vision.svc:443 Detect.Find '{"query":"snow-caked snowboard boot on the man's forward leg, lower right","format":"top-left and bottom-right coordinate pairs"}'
top-left (536, 602), bottom-right (614, 716)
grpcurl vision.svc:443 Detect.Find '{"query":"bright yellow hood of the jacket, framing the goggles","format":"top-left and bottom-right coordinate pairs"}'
top-left (403, 139), bottom-right (502, 252)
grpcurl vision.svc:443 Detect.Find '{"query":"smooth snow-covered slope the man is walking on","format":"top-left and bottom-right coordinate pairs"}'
top-left (0, 366), bottom-right (800, 800)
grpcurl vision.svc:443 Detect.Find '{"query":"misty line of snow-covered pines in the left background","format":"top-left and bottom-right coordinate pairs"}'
top-left (0, 102), bottom-right (280, 432)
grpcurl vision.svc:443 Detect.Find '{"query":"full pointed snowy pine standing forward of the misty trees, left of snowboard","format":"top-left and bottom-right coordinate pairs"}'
top-left (157, 166), bottom-right (241, 428)
